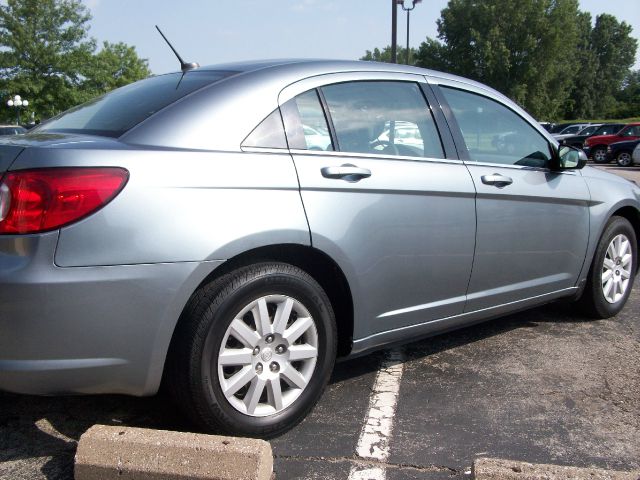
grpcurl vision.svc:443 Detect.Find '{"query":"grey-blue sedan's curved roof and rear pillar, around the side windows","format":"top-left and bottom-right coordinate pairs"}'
top-left (125, 59), bottom-right (553, 151)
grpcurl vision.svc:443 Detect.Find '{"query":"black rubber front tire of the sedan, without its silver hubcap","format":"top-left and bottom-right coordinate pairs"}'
top-left (578, 217), bottom-right (638, 319)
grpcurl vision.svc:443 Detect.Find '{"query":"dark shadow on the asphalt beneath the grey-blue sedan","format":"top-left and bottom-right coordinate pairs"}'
top-left (0, 303), bottom-right (600, 480)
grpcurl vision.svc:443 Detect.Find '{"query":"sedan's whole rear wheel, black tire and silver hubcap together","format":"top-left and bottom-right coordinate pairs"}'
top-left (168, 263), bottom-right (337, 438)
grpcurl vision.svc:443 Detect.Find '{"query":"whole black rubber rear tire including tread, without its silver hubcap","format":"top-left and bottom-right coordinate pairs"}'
top-left (166, 263), bottom-right (337, 438)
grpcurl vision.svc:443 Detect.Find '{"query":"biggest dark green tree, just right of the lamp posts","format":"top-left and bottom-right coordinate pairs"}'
top-left (416, 0), bottom-right (579, 119)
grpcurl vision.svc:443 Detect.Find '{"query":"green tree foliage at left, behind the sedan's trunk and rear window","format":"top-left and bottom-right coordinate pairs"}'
top-left (0, 0), bottom-right (150, 123)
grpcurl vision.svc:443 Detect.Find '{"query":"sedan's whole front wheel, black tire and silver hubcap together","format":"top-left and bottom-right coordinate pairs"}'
top-left (579, 217), bottom-right (638, 318)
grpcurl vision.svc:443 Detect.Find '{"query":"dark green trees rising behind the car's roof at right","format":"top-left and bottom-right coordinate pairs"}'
top-left (364, 0), bottom-right (637, 120)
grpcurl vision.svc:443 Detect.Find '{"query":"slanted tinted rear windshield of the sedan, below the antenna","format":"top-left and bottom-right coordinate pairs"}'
top-left (34, 71), bottom-right (236, 137)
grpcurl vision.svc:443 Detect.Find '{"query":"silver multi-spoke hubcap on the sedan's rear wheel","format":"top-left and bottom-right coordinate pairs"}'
top-left (218, 295), bottom-right (318, 417)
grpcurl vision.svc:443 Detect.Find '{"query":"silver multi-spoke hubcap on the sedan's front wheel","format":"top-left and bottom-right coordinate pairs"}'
top-left (602, 235), bottom-right (633, 303)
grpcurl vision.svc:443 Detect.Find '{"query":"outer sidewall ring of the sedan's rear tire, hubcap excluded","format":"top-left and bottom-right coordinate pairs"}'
top-left (199, 271), bottom-right (336, 437)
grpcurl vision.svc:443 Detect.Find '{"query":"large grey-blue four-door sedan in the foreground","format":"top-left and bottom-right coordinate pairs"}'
top-left (0, 60), bottom-right (640, 437)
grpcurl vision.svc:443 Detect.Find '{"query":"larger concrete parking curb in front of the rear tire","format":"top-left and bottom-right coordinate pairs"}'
top-left (75, 425), bottom-right (273, 480)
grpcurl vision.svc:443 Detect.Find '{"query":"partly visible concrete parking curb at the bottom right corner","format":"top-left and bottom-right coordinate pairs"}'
top-left (473, 458), bottom-right (640, 480)
